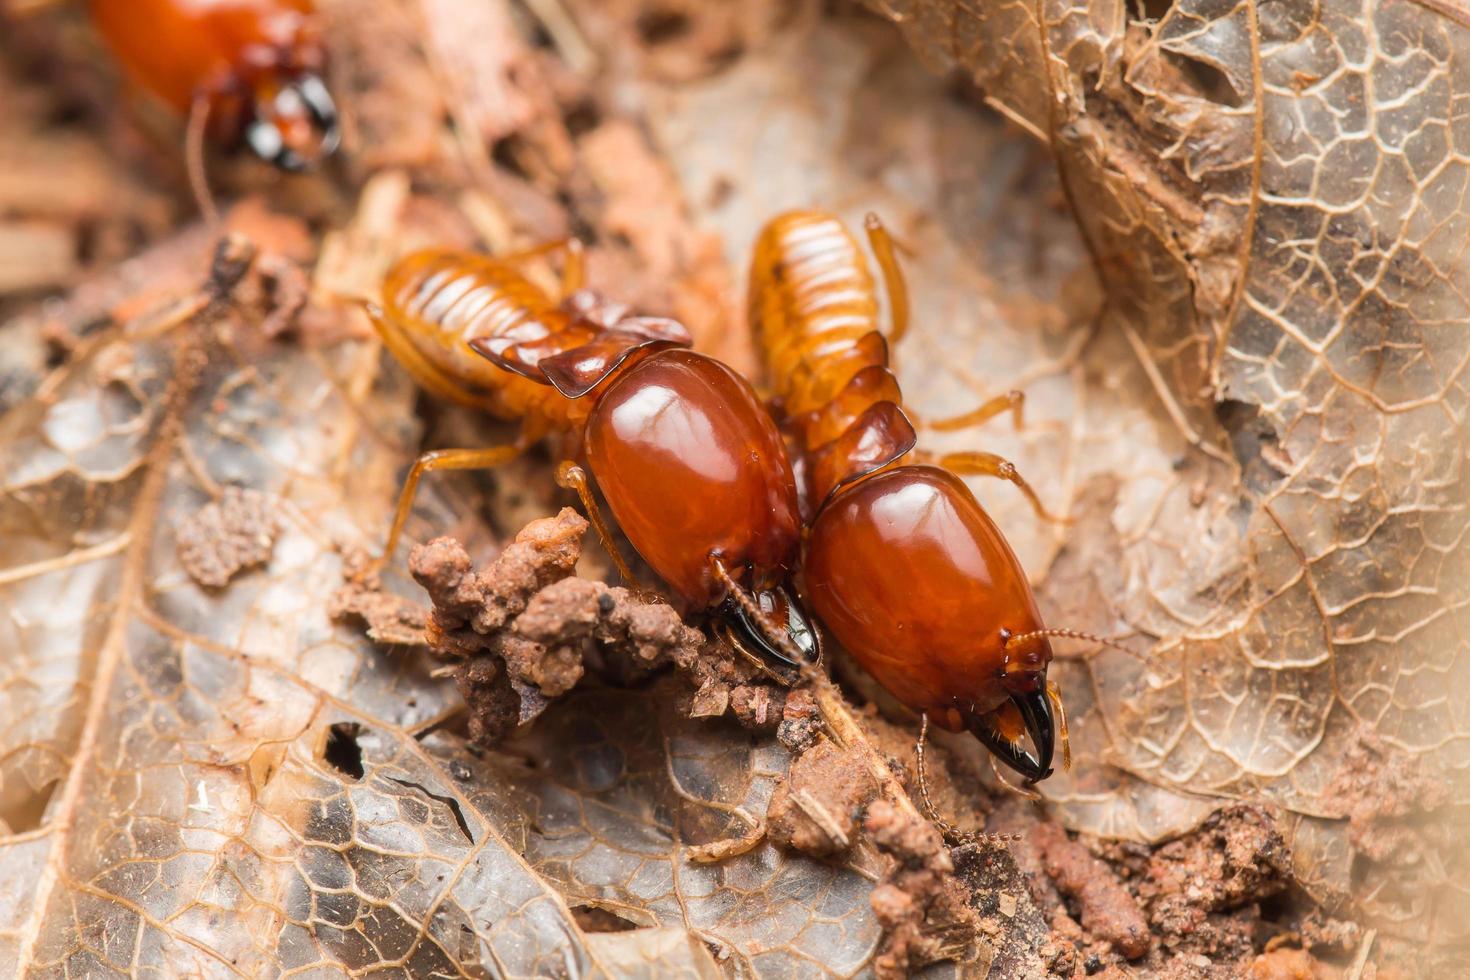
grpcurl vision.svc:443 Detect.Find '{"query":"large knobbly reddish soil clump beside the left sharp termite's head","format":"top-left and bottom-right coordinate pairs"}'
top-left (409, 507), bottom-right (706, 745)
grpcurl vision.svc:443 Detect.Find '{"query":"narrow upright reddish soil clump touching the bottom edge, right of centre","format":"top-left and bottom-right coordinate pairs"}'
top-left (863, 799), bottom-right (980, 980)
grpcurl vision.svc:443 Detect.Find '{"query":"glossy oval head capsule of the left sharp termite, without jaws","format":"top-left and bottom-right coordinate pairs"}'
top-left (585, 350), bottom-right (801, 608)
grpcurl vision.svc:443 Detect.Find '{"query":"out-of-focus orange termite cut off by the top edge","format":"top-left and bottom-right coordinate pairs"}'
top-left (90, 0), bottom-right (338, 219)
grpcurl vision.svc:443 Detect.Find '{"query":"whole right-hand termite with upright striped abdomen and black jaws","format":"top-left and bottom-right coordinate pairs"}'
top-left (750, 212), bottom-right (1066, 780)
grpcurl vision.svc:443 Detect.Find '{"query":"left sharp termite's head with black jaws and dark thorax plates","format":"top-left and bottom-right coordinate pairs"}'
top-left (472, 333), bottom-right (817, 661)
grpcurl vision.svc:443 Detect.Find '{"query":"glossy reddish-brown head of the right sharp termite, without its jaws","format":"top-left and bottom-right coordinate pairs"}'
top-left (803, 466), bottom-right (1051, 730)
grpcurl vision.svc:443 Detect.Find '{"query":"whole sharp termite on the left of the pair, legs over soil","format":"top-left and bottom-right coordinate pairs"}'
top-left (368, 239), bottom-right (819, 661)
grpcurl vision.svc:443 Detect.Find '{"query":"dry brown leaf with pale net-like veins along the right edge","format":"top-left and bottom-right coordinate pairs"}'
top-left (869, 0), bottom-right (1470, 942)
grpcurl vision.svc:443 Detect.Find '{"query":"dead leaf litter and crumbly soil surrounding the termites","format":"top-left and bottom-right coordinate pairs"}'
top-left (0, 0), bottom-right (1466, 976)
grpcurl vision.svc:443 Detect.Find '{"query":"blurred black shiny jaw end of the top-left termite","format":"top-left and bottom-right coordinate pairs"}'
top-left (245, 72), bottom-right (341, 172)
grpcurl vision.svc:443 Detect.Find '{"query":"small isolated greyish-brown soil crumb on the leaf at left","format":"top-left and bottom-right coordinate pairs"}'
top-left (176, 486), bottom-right (281, 589)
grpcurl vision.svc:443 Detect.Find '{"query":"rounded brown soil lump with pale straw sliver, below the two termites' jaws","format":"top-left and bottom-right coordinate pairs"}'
top-left (766, 739), bottom-right (878, 858)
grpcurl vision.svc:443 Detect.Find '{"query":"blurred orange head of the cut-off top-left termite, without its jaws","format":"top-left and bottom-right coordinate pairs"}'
top-left (90, 0), bottom-right (315, 112)
